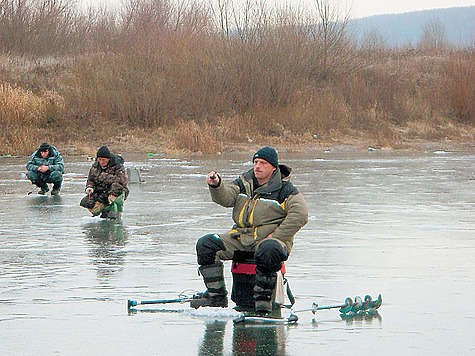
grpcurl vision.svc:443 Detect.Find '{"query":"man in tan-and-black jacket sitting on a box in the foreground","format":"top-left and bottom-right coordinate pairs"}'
top-left (190, 147), bottom-right (308, 313)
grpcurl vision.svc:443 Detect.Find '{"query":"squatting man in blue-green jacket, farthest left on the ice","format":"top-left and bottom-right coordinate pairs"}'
top-left (26, 142), bottom-right (64, 195)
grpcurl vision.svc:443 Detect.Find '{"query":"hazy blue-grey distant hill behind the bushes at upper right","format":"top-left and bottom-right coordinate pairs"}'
top-left (349, 6), bottom-right (475, 47)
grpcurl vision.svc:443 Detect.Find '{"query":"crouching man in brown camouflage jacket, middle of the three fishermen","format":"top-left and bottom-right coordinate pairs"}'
top-left (80, 146), bottom-right (129, 219)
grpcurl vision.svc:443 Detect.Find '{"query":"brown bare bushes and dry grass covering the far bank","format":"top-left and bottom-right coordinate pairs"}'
top-left (0, 0), bottom-right (475, 154)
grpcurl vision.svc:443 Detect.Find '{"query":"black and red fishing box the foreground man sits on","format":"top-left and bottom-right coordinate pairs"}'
top-left (231, 251), bottom-right (285, 309)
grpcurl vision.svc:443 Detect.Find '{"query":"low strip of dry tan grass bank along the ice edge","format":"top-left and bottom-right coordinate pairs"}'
top-left (0, 128), bottom-right (475, 157)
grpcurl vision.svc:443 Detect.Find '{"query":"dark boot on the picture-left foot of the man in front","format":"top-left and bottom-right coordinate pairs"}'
top-left (190, 262), bottom-right (228, 309)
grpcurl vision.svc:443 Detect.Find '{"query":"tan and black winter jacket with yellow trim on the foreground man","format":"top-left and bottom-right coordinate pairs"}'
top-left (209, 165), bottom-right (308, 253)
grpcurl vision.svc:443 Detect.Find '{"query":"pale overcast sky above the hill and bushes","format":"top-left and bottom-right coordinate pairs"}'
top-left (77, 0), bottom-right (475, 17)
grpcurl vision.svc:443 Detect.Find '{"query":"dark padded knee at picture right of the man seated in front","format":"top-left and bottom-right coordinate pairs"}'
top-left (254, 239), bottom-right (289, 273)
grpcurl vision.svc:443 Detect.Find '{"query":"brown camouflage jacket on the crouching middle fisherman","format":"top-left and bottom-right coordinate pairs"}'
top-left (86, 154), bottom-right (129, 204)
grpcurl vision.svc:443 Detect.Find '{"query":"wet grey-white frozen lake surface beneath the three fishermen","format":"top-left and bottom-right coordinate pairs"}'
top-left (0, 151), bottom-right (475, 356)
